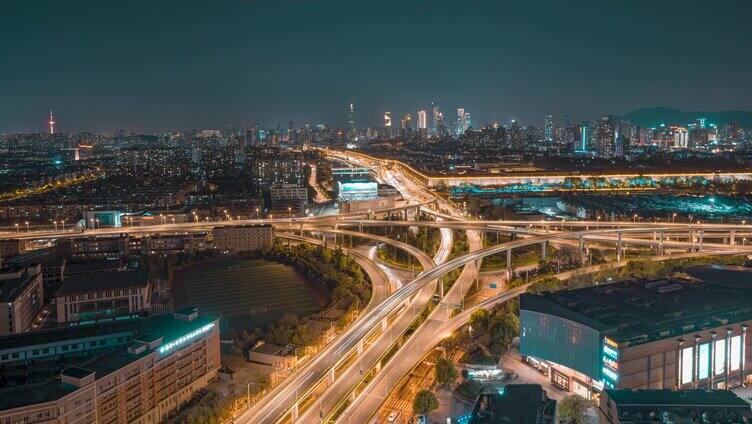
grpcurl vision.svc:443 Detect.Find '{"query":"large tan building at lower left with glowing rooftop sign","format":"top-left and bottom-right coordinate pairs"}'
top-left (0, 308), bottom-right (220, 424)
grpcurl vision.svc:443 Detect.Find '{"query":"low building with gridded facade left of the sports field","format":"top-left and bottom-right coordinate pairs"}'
top-left (55, 269), bottom-right (151, 323)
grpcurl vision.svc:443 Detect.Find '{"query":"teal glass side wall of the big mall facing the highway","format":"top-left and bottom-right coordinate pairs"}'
top-left (520, 309), bottom-right (604, 380)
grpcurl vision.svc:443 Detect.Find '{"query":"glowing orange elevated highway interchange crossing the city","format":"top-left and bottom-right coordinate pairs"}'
top-left (8, 151), bottom-right (752, 424)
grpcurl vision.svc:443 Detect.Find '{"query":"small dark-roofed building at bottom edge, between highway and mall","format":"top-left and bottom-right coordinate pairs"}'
top-left (470, 384), bottom-right (556, 424)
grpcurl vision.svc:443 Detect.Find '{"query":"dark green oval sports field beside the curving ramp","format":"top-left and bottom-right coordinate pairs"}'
top-left (173, 258), bottom-right (327, 329)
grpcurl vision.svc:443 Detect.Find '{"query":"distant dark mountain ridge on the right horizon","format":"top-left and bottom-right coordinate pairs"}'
top-left (622, 107), bottom-right (752, 127)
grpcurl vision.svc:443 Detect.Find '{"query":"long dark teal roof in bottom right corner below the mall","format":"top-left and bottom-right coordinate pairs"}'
top-left (606, 389), bottom-right (752, 424)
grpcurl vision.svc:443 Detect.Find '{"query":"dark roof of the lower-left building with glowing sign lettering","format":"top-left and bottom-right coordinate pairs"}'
top-left (0, 314), bottom-right (216, 411)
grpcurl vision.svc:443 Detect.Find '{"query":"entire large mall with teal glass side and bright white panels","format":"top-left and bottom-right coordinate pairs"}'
top-left (520, 267), bottom-right (752, 399)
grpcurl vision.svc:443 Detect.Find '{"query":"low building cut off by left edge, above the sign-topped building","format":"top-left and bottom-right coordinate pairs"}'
top-left (0, 264), bottom-right (44, 334)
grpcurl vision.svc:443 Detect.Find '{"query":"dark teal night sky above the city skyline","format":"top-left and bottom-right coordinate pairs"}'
top-left (0, 0), bottom-right (752, 132)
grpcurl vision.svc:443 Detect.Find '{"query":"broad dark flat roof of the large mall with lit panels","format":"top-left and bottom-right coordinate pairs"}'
top-left (520, 267), bottom-right (752, 344)
